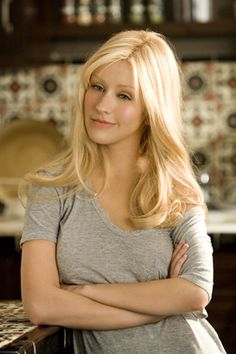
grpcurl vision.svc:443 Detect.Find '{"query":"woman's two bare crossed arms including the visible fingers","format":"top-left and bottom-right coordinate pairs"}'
top-left (21, 240), bottom-right (208, 330)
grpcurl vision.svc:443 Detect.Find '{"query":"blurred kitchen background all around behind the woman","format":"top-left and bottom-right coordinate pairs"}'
top-left (0, 0), bottom-right (236, 354)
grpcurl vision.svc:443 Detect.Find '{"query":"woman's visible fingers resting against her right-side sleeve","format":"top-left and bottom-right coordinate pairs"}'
top-left (169, 240), bottom-right (189, 278)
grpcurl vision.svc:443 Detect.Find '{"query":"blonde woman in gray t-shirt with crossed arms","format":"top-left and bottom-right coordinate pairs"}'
top-left (21, 31), bottom-right (225, 354)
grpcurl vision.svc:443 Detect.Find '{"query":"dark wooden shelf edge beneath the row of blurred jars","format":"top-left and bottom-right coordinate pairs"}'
top-left (28, 20), bottom-right (236, 40)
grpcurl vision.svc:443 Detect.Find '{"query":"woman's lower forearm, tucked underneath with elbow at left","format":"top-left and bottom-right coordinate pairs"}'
top-left (24, 289), bottom-right (160, 330)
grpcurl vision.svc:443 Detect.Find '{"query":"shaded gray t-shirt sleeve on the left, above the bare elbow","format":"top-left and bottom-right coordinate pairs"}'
top-left (20, 186), bottom-right (61, 245)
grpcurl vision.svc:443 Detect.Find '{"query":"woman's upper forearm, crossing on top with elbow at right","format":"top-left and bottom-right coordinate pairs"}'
top-left (80, 278), bottom-right (208, 316)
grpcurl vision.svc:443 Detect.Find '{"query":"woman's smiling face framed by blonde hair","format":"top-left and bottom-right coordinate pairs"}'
top-left (84, 61), bottom-right (144, 152)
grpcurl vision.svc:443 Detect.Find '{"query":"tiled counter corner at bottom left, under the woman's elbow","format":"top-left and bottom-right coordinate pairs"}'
top-left (0, 300), bottom-right (73, 354)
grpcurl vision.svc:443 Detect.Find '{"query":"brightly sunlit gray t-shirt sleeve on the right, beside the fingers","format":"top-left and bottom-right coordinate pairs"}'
top-left (172, 207), bottom-right (213, 299)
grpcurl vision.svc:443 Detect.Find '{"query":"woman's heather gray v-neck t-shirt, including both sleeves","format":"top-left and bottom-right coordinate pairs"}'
top-left (21, 187), bottom-right (225, 354)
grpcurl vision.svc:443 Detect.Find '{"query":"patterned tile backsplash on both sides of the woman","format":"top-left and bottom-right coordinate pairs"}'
top-left (0, 61), bottom-right (236, 205)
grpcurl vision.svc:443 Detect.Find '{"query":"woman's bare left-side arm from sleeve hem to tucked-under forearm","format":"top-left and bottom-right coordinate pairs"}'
top-left (21, 240), bottom-right (160, 330)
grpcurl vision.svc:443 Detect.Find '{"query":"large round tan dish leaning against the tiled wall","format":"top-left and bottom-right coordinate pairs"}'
top-left (0, 119), bottom-right (64, 203)
